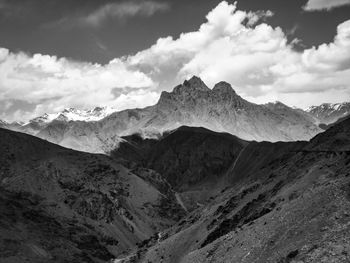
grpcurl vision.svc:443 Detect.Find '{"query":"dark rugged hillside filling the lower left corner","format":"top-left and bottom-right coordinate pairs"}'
top-left (0, 129), bottom-right (186, 262)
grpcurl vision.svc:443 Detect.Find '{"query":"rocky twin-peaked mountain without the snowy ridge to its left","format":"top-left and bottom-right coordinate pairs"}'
top-left (101, 77), bottom-right (320, 141)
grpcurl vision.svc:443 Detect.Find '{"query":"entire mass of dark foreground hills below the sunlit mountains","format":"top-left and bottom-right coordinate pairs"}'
top-left (0, 112), bottom-right (350, 263)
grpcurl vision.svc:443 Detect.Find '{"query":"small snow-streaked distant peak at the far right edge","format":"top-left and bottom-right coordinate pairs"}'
top-left (306, 102), bottom-right (350, 124)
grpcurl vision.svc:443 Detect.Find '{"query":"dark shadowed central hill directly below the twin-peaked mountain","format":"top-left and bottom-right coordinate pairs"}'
top-left (111, 126), bottom-right (248, 210)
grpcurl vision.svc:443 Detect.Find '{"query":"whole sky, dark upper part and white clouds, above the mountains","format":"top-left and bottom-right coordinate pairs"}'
top-left (0, 0), bottom-right (350, 121)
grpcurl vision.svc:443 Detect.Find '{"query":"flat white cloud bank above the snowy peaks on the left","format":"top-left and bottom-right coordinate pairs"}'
top-left (0, 48), bottom-right (156, 121)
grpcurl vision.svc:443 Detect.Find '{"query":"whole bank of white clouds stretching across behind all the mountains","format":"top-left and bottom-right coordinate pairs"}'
top-left (0, 1), bottom-right (350, 120)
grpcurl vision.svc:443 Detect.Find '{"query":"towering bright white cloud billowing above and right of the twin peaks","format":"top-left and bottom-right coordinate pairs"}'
top-left (128, 1), bottom-right (350, 106)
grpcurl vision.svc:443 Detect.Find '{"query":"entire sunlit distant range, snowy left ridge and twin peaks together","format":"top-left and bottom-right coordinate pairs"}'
top-left (2, 77), bottom-right (321, 153)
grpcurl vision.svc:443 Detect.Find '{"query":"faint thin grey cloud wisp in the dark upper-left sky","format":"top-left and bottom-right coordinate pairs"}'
top-left (81, 1), bottom-right (170, 26)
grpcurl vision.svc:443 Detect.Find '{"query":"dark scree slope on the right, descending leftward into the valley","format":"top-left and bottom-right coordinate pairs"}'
top-left (126, 119), bottom-right (350, 263)
